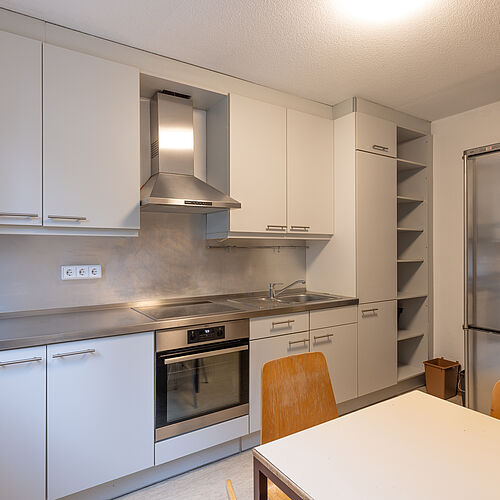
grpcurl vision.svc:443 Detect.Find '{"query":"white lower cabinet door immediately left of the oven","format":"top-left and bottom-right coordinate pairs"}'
top-left (47, 332), bottom-right (154, 499)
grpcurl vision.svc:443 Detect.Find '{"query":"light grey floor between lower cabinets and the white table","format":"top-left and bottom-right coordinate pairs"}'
top-left (121, 387), bottom-right (462, 500)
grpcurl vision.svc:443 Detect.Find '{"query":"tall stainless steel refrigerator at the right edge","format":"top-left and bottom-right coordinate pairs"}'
top-left (464, 143), bottom-right (500, 413)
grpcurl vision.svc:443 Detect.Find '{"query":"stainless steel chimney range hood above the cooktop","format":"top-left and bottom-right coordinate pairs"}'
top-left (141, 92), bottom-right (241, 213)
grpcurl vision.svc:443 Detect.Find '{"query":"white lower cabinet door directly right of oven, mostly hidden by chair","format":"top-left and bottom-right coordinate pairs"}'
top-left (249, 332), bottom-right (309, 433)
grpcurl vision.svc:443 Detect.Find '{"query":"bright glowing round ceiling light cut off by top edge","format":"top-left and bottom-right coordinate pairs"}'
top-left (333, 0), bottom-right (429, 23)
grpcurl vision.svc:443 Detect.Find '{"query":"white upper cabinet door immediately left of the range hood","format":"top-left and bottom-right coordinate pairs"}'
top-left (43, 45), bottom-right (140, 229)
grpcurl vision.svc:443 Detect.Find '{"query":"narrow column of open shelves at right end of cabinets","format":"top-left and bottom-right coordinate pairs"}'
top-left (396, 127), bottom-right (432, 382)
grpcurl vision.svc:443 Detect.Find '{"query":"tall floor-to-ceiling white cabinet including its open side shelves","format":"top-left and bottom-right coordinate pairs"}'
top-left (307, 98), bottom-right (432, 396)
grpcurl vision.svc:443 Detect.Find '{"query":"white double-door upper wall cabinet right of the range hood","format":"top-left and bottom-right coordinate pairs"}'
top-left (207, 94), bottom-right (333, 240)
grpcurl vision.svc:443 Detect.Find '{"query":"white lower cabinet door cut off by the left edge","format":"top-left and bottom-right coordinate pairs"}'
top-left (0, 347), bottom-right (46, 500)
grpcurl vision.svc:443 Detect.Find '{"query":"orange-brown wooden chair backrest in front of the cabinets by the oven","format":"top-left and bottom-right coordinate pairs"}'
top-left (261, 352), bottom-right (338, 444)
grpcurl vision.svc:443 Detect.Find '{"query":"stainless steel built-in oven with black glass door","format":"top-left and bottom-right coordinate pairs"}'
top-left (155, 320), bottom-right (249, 441)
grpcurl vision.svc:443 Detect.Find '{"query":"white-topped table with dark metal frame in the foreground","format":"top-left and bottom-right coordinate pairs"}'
top-left (254, 391), bottom-right (500, 500)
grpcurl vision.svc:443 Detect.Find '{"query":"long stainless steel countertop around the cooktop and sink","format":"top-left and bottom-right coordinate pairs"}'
top-left (0, 290), bottom-right (358, 350)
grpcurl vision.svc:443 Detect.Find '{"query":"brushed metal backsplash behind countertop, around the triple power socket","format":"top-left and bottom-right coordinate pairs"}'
top-left (0, 213), bottom-right (306, 312)
